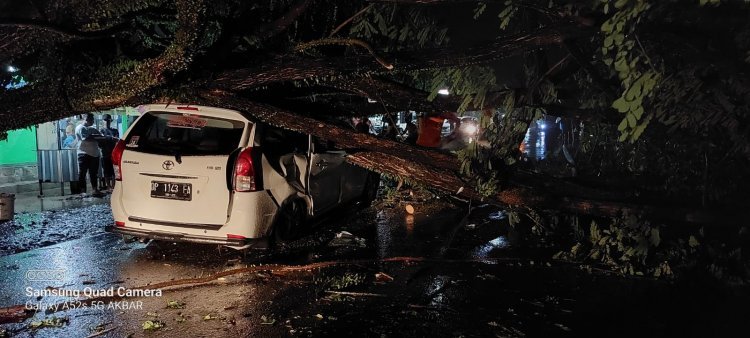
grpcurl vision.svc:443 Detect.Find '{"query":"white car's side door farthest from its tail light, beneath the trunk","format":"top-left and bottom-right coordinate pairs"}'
top-left (308, 137), bottom-right (346, 214)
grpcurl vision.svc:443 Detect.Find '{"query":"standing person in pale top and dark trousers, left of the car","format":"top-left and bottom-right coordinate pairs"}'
top-left (76, 113), bottom-right (101, 196)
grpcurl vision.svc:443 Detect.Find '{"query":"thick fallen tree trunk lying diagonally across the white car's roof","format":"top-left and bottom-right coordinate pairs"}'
top-left (202, 91), bottom-right (734, 224)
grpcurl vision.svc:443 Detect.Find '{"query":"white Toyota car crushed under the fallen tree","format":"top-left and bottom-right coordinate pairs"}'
top-left (111, 104), bottom-right (379, 249)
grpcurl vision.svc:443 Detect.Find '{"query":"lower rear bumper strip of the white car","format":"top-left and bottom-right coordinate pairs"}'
top-left (107, 226), bottom-right (268, 249)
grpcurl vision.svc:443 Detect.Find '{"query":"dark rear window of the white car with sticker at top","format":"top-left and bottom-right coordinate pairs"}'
top-left (125, 111), bottom-right (246, 156)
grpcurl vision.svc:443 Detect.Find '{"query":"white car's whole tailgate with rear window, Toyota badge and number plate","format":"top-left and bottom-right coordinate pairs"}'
top-left (122, 107), bottom-right (252, 226)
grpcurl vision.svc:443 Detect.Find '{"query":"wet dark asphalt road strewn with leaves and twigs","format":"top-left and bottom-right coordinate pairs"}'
top-left (0, 199), bottom-right (750, 337)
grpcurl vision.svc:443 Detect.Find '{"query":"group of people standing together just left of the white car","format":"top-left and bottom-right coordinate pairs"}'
top-left (71, 113), bottom-right (120, 196)
